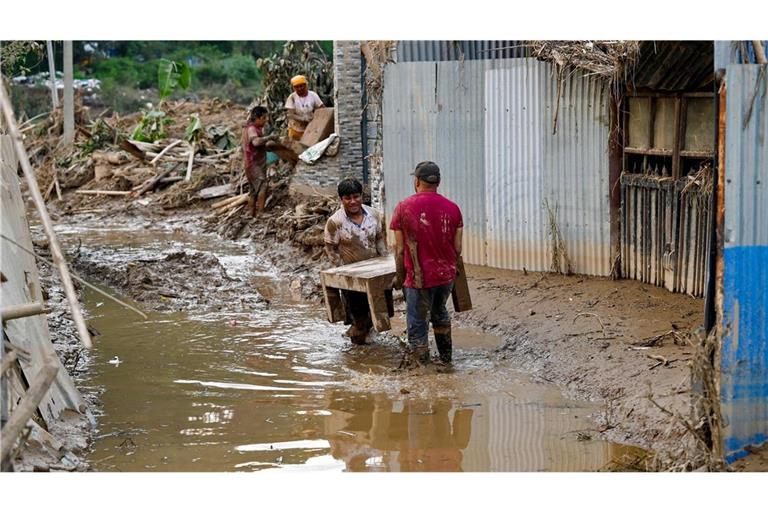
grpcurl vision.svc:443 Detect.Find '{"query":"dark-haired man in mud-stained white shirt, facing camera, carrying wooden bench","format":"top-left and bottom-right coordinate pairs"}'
top-left (324, 179), bottom-right (387, 345)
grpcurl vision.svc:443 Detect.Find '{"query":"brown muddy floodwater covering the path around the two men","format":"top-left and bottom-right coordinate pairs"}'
top-left (59, 216), bottom-right (631, 471)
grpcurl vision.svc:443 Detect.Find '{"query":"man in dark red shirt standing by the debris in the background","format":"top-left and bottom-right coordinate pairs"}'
top-left (242, 106), bottom-right (279, 217)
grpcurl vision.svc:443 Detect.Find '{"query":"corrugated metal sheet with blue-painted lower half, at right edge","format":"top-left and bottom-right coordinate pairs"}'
top-left (720, 65), bottom-right (768, 460)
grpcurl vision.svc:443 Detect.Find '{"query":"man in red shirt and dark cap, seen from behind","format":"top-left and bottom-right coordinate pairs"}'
top-left (389, 162), bottom-right (464, 367)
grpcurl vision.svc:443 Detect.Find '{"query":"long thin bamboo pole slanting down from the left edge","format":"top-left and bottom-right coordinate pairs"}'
top-left (0, 84), bottom-right (93, 348)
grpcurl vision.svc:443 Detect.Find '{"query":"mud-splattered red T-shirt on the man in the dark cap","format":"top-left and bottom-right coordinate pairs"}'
top-left (389, 192), bottom-right (464, 288)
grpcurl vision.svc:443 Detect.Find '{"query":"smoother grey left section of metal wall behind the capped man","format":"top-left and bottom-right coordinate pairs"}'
top-left (383, 61), bottom-right (485, 265)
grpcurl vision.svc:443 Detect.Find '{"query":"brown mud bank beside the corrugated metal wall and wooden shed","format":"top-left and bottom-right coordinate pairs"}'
top-left (456, 267), bottom-right (703, 462)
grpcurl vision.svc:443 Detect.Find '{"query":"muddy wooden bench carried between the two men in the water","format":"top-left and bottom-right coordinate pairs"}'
top-left (320, 255), bottom-right (472, 332)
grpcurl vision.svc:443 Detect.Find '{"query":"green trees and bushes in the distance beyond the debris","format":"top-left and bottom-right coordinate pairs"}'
top-left (3, 41), bottom-right (333, 115)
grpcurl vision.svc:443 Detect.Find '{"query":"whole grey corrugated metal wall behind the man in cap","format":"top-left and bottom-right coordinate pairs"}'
top-left (383, 59), bottom-right (610, 275)
